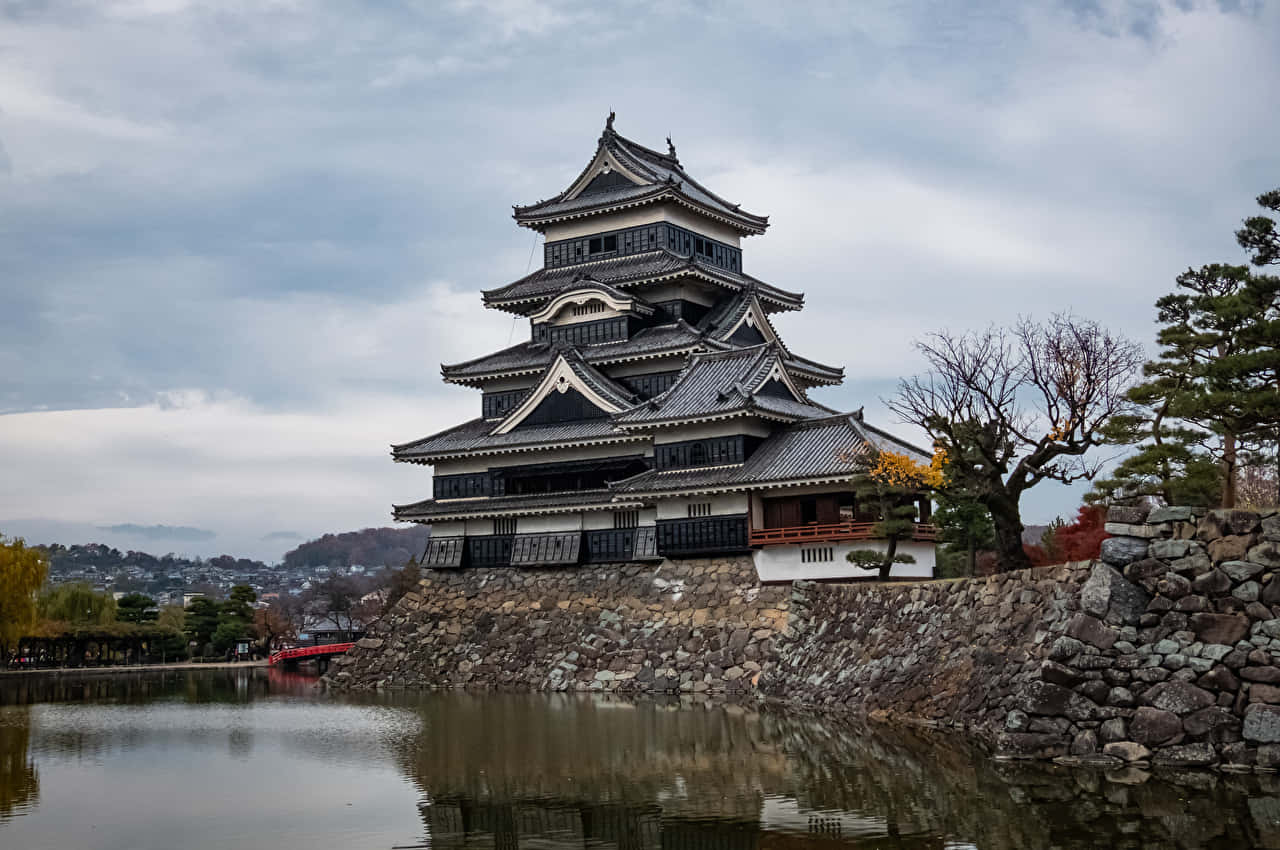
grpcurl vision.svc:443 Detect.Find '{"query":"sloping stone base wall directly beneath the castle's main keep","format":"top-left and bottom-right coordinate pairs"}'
top-left (326, 558), bottom-right (790, 693)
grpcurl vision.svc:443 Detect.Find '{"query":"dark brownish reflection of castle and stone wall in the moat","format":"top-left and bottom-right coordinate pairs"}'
top-left (401, 695), bottom-right (1280, 850)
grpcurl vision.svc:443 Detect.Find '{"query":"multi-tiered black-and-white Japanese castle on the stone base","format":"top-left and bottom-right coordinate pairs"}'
top-left (393, 113), bottom-right (934, 581)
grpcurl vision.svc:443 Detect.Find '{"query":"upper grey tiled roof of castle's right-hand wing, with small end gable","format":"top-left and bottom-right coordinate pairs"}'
top-left (613, 343), bottom-right (832, 428)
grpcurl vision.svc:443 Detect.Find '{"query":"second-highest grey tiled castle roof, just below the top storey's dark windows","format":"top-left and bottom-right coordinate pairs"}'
top-left (481, 248), bottom-right (804, 314)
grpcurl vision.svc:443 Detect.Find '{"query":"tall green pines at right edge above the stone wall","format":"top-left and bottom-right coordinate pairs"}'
top-left (1087, 191), bottom-right (1280, 507)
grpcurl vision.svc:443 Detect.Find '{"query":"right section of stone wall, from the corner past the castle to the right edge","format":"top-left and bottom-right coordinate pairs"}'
top-left (762, 508), bottom-right (1280, 769)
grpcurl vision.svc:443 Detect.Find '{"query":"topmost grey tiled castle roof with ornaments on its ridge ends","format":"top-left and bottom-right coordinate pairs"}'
top-left (515, 118), bottom-right (769, 233)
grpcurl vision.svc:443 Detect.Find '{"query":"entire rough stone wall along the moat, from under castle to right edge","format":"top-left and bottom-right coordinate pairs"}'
top-left (328, 507), bottom-right (1280, 771)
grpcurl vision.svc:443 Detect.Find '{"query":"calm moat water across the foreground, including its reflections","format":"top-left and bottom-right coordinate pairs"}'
top-left (0, 670), bottom-right (1280, 850)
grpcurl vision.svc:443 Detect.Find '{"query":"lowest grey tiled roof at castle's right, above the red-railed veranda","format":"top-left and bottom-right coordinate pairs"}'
top-left (612, 413), bottom-right (929, 497)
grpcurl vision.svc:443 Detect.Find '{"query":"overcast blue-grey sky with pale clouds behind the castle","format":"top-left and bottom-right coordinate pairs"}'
top-left (0, 0), bottom-right (1280, 558)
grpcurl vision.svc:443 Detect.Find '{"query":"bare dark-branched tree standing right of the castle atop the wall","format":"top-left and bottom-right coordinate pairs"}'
top-left (886, 314), bottom-right (1142, 570)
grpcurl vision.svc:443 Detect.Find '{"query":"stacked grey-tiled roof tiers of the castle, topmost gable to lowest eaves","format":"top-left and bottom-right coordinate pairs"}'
top-left (392, 114), bottom-right (928, 521)
